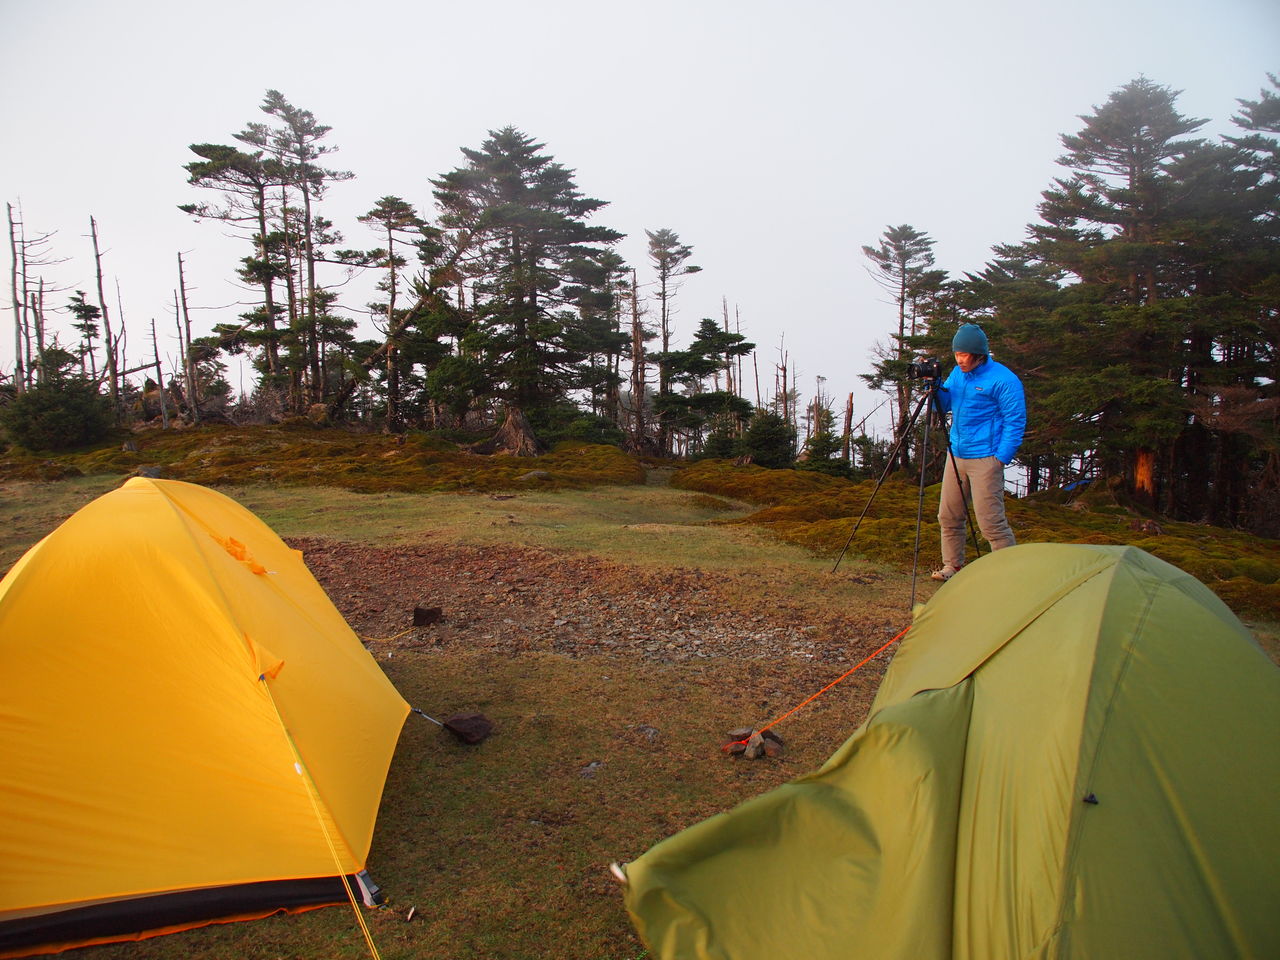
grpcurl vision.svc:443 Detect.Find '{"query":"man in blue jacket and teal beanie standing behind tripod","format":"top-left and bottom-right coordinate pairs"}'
top-left (933, 324), bottom-right (1027, 580)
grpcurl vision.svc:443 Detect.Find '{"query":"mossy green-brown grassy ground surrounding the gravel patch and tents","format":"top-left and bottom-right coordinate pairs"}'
top-left (0, 431), bottom-right (1280, 960)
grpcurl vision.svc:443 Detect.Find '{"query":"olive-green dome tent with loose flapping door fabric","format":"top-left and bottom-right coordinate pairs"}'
top-left (625, 544), bottom-right (1280, 960)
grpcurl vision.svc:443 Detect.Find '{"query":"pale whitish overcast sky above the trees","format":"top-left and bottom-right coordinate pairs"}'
top-left (0, 0), bottom-right (1280, 428)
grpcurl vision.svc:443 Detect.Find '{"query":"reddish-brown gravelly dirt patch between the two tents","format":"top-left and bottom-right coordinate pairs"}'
top-left (291, 539), bottom-right (897, 672)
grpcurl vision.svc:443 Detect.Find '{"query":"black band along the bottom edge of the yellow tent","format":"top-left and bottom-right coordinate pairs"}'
top-left (0, 876), bottom-right (376, 956)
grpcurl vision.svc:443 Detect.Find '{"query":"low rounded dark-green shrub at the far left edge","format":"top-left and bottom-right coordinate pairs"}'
top-left (0, 376), bottom-right (111, 451)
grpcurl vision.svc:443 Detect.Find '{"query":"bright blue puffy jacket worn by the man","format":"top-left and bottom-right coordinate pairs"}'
top-left (938, 357), bottom-right (1027, 463)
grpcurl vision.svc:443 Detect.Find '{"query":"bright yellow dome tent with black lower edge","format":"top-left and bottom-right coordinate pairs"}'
top-left (0, 479), bottom-right (408, 956)
